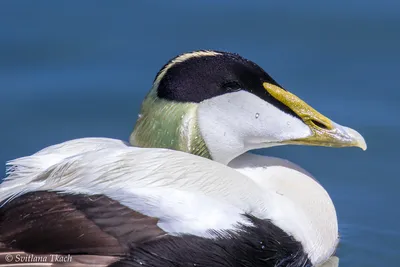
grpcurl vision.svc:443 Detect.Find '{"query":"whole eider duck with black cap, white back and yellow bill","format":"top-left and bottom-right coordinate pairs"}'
top-left (0, 51), bottom-right (366, 267)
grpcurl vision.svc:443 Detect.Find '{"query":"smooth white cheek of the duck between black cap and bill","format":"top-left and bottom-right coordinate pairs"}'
top-left (198, 91), bottom-right (311, 161)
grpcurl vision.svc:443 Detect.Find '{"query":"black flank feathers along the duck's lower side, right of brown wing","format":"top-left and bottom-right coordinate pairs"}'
top-left (111, 215), bottom-right (312, 267)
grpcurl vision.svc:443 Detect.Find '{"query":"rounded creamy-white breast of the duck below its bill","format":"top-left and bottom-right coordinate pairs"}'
top-left (229, 153), bottom-right (339, 263)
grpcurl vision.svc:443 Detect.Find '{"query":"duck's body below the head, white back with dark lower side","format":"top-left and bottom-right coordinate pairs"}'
top-left (0, 138), bottom-right (337, 266)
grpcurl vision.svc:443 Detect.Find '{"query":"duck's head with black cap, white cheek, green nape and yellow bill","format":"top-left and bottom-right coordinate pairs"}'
top-left (130, 51), bottom-right (367, 164)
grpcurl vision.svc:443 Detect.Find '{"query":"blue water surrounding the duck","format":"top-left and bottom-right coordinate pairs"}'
top-left (0, 0), bottom-right (400, 267)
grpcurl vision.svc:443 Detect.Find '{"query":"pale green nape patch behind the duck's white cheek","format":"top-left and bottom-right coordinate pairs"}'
top-left (129, 87), bottom-right (211, 159)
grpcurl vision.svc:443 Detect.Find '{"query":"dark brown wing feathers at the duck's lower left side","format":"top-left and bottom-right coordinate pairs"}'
top-left (0, 191), bottom-right (165, 266)
